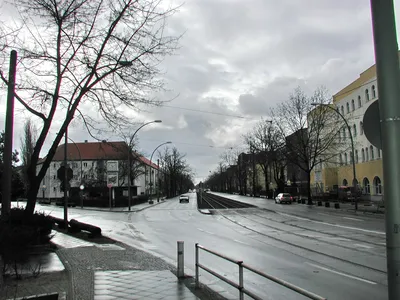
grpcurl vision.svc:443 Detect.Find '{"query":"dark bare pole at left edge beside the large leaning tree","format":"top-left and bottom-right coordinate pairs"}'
top-left (1, 50), bottom-right (17, 216)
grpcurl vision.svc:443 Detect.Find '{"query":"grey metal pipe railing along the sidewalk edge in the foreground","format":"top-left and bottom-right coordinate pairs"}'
top-left (195, 243), bottom-right (327, 300)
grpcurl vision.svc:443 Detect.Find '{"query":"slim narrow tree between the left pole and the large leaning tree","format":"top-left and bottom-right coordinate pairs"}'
top-left (21, 119), bottom-right (37, 195)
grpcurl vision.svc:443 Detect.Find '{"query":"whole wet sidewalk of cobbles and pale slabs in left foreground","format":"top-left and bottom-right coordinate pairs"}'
top-left (0, 232), bottom-right (228, 300)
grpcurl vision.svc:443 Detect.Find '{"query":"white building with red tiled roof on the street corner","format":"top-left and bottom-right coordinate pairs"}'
top-left (37, 141), bottom-right (158, 199)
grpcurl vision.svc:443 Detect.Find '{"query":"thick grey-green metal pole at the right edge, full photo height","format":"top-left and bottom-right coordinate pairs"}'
top-left (371, 0), bottom-right (400, 300)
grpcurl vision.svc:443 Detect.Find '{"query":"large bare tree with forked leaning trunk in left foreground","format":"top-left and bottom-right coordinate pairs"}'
top-left (0, 0), bottom-right (179, 217)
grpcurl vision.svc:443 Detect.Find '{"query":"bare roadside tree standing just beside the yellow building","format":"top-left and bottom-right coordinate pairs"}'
top-left (273, 88), bottom-right (341, 204)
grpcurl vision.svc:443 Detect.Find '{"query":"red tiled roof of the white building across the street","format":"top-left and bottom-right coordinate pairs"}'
top-left (38, 142), bottom-right (158, 169)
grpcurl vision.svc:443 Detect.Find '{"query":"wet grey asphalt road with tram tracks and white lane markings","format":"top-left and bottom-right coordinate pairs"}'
top-left (32, 194), bottom-right (388, 299)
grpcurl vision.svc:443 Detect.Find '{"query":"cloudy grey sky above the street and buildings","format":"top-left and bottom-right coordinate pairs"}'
top-left (0, 0), bottom-right (400, 182)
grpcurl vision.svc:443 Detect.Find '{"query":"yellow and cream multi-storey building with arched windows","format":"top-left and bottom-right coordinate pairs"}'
top-left (311, 57), bottom-right (392, 200)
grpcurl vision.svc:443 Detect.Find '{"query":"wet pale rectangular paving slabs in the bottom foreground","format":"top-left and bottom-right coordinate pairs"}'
top-left (94, 270), bottom-right (199, 300)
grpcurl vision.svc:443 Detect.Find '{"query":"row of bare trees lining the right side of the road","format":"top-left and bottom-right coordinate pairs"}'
top-left (205, 87), bottom-right (349, 201)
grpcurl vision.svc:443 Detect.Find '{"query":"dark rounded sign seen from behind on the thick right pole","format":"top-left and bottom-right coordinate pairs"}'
top-left (363, 100), bottom-right (382, 149)
